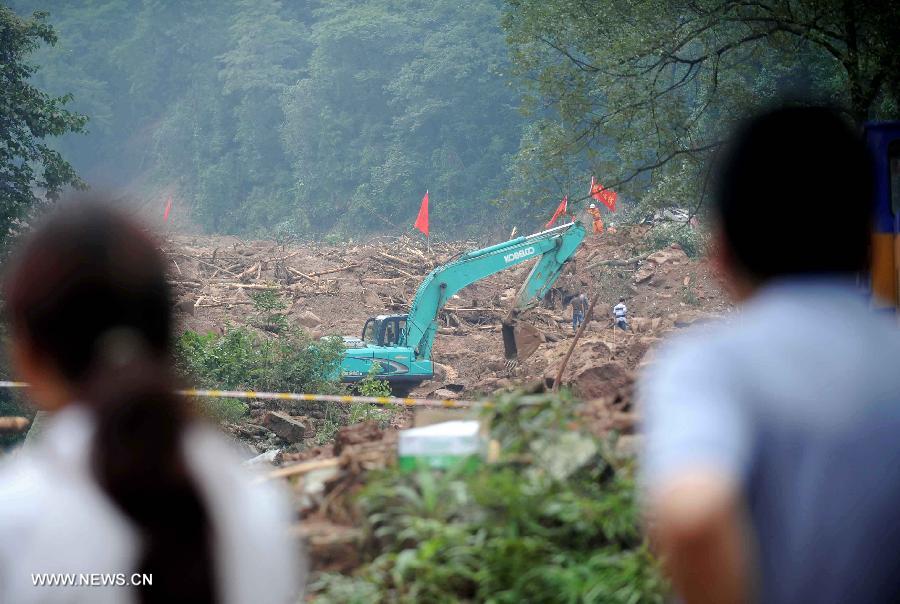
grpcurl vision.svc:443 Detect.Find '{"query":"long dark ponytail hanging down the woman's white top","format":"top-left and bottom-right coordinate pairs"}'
top-left (85, 331), bottom-right (216, 603)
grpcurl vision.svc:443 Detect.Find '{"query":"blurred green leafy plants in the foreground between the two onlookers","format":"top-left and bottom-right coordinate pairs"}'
top-left (314, 395), bottom-right (664, 603)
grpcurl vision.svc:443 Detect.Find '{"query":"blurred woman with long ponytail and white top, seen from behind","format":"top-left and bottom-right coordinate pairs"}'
top-left (0, 202), bottom-right (306, 604)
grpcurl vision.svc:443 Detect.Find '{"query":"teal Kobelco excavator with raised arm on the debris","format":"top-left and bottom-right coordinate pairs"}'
top-left (341, 222), bottom-right (585, 392)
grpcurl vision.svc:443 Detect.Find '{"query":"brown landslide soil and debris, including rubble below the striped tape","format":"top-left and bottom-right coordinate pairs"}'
top-left (163, 224), bottom-right (730, 596)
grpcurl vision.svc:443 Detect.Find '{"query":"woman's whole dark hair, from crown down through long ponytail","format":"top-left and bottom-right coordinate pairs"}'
top-left (4, 202), bottom-right (216, 602)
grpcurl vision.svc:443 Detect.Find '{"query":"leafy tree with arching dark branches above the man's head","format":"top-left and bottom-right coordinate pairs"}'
top-left (503, 0), bottom-right (900, 222)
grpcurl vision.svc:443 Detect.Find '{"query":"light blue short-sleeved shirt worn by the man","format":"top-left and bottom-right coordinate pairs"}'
top-left (639, 280), bottom-right (900, 604)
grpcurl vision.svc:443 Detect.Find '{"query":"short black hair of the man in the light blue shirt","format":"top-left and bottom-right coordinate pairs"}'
top-left (715, 107), bottom-right (873, 282)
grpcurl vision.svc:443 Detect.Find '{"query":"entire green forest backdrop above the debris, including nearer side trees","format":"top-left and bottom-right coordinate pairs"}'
top-left (0, 0), bottom-right (900, 238)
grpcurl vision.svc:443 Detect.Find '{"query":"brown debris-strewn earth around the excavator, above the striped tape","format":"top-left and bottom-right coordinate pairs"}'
top-left (165, 226), bottom-right (729, 398)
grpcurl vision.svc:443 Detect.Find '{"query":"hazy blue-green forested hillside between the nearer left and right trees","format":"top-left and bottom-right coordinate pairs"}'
top-left (11, 0), bottom-right (521, 236)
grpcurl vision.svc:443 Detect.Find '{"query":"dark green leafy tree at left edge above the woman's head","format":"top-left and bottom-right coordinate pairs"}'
top-left (0, 5), bottom-right (87, 236)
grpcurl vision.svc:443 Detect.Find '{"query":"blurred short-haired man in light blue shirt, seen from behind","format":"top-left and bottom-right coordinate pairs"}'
top-left (638, 108), bottom-right (900, 604)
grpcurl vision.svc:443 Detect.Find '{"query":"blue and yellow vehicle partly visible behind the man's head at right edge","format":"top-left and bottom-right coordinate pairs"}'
top-left (865, 122), bottom-right (900, 307)
